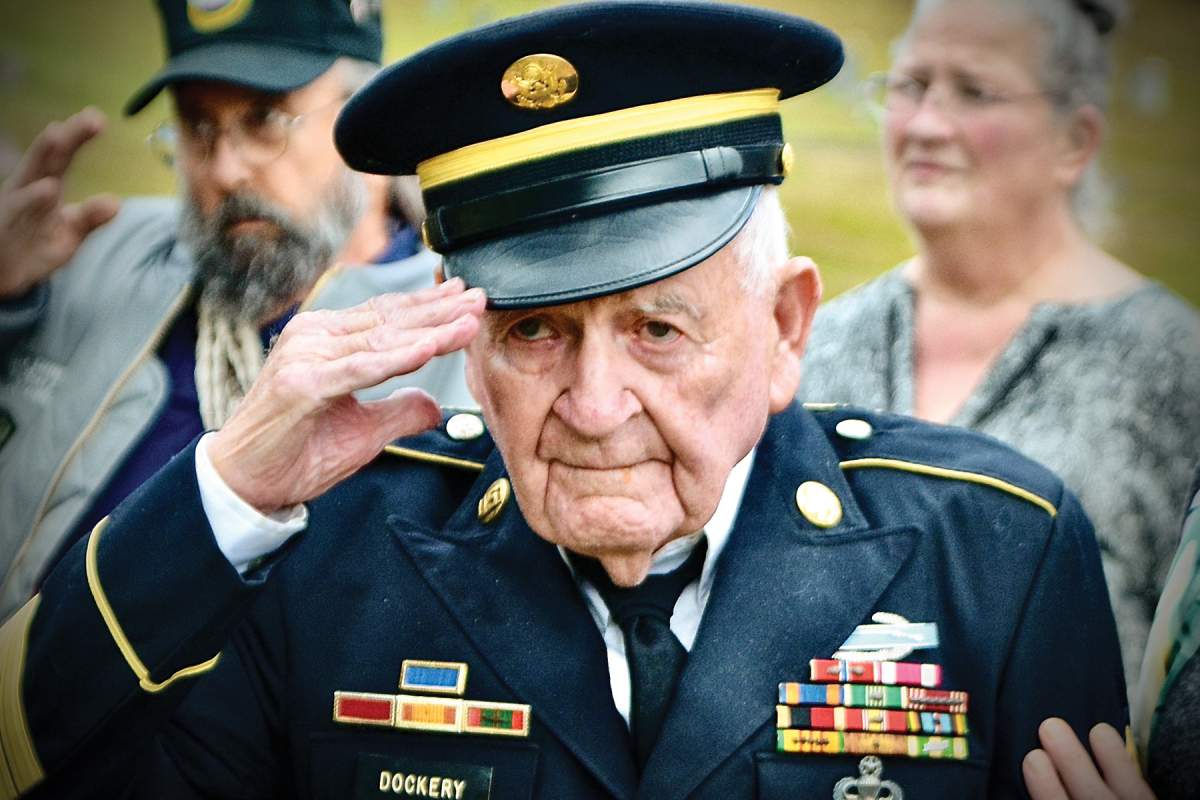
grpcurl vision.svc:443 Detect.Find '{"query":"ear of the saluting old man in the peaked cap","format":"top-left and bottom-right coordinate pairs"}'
top-left (770, 258), bottom-right (821, 414)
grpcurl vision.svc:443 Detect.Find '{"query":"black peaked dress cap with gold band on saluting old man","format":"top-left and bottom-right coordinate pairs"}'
top-left (334, 0), bottom-right (842, 308)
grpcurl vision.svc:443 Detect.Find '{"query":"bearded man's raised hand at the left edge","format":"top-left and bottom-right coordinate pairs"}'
top-left (0, 107), bottom-right (119, 300)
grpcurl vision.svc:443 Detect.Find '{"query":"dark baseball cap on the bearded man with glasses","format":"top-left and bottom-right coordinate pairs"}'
top-left (125, 0), bottom-right (383, 115)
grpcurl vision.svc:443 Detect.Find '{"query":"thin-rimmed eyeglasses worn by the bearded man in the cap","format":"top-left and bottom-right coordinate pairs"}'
top-left (146, 98), bottom-right (343, 167)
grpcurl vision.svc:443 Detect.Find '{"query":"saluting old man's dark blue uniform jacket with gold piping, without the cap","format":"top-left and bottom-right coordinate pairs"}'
top-left (11, 405), bottom-right (1124, 800)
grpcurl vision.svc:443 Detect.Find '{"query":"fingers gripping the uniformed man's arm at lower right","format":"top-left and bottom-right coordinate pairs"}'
top-left (1021, 717), bottom-right (1154, 800)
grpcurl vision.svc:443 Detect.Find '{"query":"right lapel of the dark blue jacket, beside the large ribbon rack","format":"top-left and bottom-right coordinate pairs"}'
top-left (637, 408), bottom-right (916, 800)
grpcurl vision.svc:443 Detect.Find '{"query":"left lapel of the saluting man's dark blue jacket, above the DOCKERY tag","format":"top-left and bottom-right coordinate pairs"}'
top-left (394, 453), bottom-right (637, 799)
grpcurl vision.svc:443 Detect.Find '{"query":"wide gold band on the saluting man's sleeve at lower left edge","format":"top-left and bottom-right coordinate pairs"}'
top-left (0, 595), bottom-right (46, 800)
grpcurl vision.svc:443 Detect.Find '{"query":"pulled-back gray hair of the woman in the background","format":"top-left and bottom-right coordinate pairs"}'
top-left (898, 0), bottom-right (1129, 236)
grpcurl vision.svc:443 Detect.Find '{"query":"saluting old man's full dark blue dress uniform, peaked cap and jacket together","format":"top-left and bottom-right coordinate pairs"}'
top-left (0, 0), bottom-right (1124, 800)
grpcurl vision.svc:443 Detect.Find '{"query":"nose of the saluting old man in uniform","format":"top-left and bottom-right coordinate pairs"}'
top-left (553, 336), bottom-right (642, 438)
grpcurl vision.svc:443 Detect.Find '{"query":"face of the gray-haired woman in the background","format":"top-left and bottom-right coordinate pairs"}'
top-left (884, 0), bottom-right (1069, 230)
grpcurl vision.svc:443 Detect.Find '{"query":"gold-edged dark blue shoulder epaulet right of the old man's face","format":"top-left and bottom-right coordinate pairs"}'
top-left (804, 403), bottom-right (1061, 517)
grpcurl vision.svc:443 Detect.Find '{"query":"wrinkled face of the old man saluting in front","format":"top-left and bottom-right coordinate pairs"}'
top-left (468, 247), bottom-right (794, 585)
